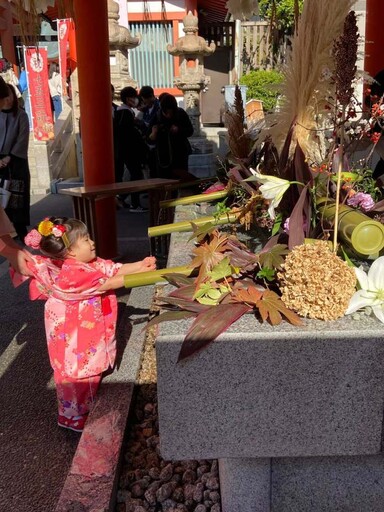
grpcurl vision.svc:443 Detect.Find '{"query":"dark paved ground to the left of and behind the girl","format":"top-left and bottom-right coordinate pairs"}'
top-left (0, 195), bottom-right (153, 512)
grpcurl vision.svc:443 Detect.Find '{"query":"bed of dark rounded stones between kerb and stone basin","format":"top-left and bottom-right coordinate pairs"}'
top-left (115, 300), bottom-right (221, 512)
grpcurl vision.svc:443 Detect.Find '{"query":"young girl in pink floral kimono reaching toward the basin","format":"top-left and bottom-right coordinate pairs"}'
top-left (25, 217), bottom-right (156, 432)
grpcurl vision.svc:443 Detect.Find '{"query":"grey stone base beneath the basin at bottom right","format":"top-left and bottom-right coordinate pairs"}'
top-left (219, 455), bottom-right (384, 512)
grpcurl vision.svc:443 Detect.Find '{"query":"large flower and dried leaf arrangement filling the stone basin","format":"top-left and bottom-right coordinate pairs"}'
top-left (142, 0), bottom-right (384, 359)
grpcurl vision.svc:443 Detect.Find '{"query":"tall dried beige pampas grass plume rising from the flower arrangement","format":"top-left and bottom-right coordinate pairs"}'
top-left (270, 0), bottom-right (355, 159)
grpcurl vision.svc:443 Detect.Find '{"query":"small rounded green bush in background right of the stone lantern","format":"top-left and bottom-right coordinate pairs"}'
top-left (240, 69), bottom-right (284, 111)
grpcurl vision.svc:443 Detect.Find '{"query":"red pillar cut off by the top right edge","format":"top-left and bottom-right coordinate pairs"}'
top-left (364, 0), bottom-right (384, 76)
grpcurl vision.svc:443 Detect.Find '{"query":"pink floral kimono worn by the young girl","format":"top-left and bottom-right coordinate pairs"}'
top-left (26, 256), bottom-right (121, 417)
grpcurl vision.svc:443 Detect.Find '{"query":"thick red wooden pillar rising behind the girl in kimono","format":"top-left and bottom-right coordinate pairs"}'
top-left (74, 0), bottom-right (117, 258)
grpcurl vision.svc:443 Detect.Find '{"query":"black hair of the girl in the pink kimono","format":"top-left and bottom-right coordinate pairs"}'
top-left (40, 217), bottom-right (88, 260)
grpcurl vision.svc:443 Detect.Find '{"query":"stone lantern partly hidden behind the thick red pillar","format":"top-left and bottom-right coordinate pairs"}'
top-left (108, 0), bottom-right (141, 97)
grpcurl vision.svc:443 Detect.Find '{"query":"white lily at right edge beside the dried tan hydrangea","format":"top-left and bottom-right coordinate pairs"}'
top-left (345, 256), bottom-right (384, 323)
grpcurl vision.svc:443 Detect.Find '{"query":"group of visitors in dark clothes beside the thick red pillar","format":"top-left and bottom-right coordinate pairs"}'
top-left (112, 85), bottom-right (196, 212)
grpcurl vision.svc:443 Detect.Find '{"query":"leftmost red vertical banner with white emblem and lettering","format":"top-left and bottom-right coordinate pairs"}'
top-left (24, 47), bottom-right (54, 140)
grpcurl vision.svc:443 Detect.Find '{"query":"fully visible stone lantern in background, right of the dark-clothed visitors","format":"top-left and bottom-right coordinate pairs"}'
top-left (167, 11), bottom-right (216, 137)
